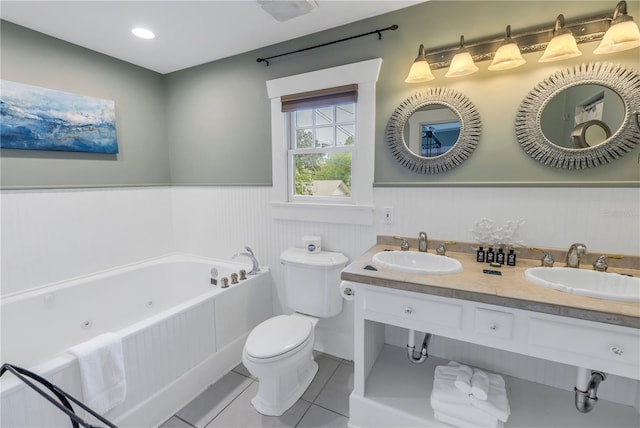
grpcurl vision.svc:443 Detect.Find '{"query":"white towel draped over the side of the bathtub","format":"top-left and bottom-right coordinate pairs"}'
top-left (69, 333), bottom-right (127, 415)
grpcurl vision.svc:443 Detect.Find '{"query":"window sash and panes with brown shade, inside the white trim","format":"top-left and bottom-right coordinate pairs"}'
top-left (282, 85), bottom-right (357, 203)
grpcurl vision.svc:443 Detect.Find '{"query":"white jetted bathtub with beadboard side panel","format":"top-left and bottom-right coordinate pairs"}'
top-left (0, 254), bottom-right (272, 427)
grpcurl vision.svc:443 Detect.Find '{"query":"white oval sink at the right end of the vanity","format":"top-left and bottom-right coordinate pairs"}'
top-left (524, 267), bottom-right (640, 303)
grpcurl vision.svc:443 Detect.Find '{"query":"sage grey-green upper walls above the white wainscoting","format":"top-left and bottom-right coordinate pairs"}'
top-left (2, 1), bottom-right (640, 186)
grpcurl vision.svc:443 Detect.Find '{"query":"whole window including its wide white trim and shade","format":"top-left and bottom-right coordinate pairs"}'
top-left (267, 58), bottom-right (382, 225)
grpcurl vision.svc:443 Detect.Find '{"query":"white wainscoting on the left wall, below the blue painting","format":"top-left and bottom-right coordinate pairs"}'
top-left (1, 187), bottom-right (174, 296)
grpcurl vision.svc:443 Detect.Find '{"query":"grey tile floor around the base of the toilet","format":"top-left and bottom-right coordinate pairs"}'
top-left (160, 353), bottom-right (353, 428)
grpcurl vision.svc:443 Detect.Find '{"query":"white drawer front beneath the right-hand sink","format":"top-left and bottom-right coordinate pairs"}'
top-left (529, 318), bottom-right (640, 365)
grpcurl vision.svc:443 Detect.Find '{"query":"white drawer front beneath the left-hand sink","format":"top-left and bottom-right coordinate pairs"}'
top-left (364, 293), bottom-right (463, 329)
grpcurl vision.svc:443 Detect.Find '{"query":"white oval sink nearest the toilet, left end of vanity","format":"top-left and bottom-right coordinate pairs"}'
top-left (372, 251), bottom-right (462, 275)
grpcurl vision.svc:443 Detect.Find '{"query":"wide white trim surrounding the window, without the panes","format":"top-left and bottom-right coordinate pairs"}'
top-left (266, 58), bottom-right (382, 225)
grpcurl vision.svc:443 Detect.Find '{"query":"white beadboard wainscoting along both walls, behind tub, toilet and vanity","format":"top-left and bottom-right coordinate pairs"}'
top-left (2, 186), bottom-right (640, 398)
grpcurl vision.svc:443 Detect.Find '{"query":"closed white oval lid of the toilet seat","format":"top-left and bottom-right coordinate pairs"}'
top-left (245, 315), bottom-right (313, 358)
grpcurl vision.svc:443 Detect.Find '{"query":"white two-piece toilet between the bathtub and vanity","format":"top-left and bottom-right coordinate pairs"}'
top-left (242, 248), bottom-right (348, 416)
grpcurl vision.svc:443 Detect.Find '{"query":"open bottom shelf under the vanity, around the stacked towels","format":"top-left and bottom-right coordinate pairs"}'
top-left (350, 345), bottom-right (640, 428)
